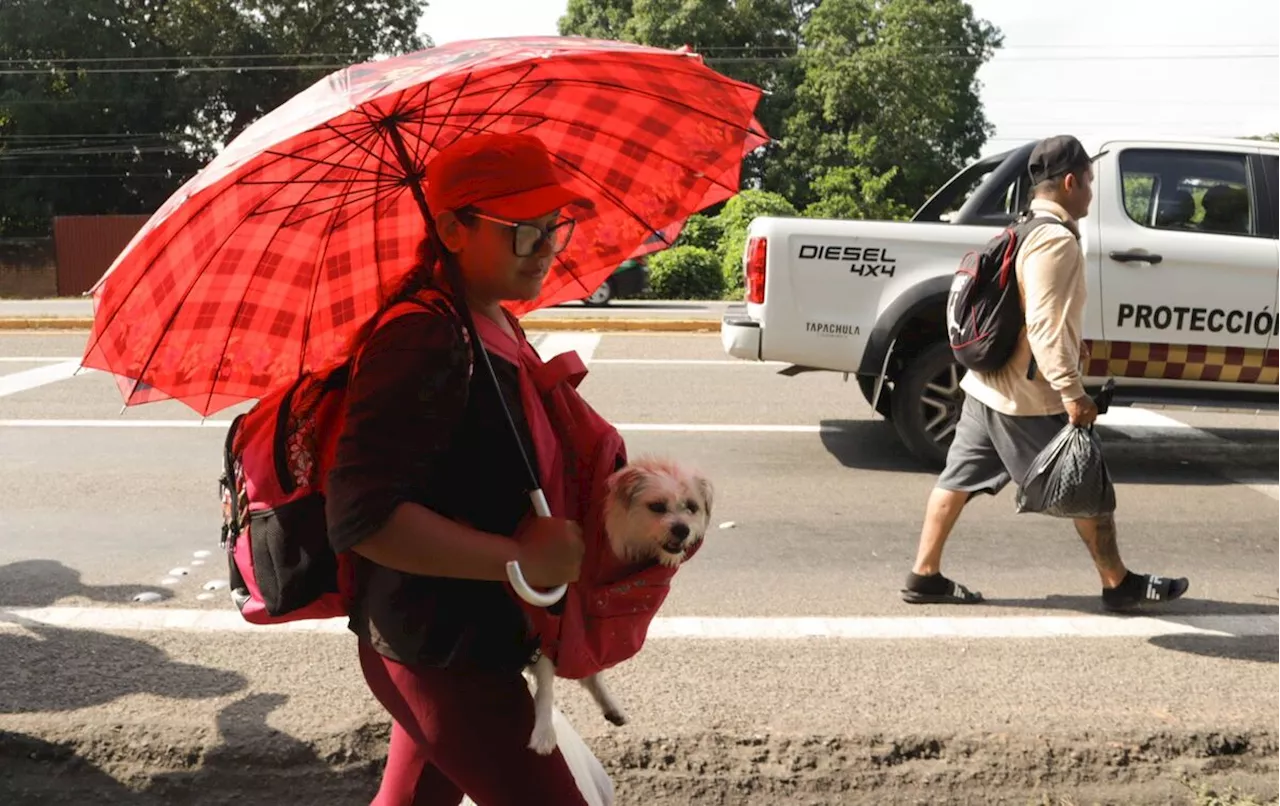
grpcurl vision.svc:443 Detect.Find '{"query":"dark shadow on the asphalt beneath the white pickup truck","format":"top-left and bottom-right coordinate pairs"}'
top-left (822, 420), bottom-right (1280, 487)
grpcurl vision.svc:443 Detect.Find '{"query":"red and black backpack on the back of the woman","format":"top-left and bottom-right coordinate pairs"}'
top-left (219, 297), bottom-right (440, 624)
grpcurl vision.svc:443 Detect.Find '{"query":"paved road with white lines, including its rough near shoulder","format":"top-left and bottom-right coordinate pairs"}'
top-left (0, 334), bottom-right (1280, 803)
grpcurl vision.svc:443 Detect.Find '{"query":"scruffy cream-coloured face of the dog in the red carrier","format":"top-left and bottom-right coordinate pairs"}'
top-left (604, 459), bottom-right (713, 565)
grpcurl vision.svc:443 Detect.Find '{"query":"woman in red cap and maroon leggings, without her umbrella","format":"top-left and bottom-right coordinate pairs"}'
top-left (328, 134), bottom-right (585, 806)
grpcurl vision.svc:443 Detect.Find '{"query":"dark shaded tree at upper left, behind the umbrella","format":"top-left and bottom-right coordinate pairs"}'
top-left (0, 0), bottom-right (424, 237)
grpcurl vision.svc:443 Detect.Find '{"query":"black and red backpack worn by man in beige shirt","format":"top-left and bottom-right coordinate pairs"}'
top-left (947, 216), bottom-right (1059, 372)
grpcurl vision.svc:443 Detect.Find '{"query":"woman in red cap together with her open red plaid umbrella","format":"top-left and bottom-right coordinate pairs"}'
top-left (82, 37), bottom-right (768, 806)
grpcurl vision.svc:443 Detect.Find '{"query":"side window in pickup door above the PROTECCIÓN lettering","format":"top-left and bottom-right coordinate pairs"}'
top-left (1120, 148), bottom-right (1258, 235)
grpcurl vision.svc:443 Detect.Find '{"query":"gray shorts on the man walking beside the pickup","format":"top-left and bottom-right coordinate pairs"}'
top-left (937, 395), bottom-right (1070, 498)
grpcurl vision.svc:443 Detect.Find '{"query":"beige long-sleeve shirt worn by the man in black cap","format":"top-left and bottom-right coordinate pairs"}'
top-left (960, 198), bottom-right (1088, 416)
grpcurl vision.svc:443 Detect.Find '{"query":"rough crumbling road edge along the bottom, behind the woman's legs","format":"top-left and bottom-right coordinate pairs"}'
top-left (0, 720), bottom-right (1277, 806)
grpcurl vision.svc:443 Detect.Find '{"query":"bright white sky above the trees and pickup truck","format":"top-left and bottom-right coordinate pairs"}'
top-left (422, 0), bottom-right (1280, 158)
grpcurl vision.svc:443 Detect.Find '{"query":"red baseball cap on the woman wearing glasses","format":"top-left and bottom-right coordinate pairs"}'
top-left (426, 133), bottom-right (593, 221)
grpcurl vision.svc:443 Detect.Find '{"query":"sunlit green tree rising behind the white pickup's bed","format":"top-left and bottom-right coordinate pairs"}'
top-left (764, 0), bottom-right (1002, 215)
